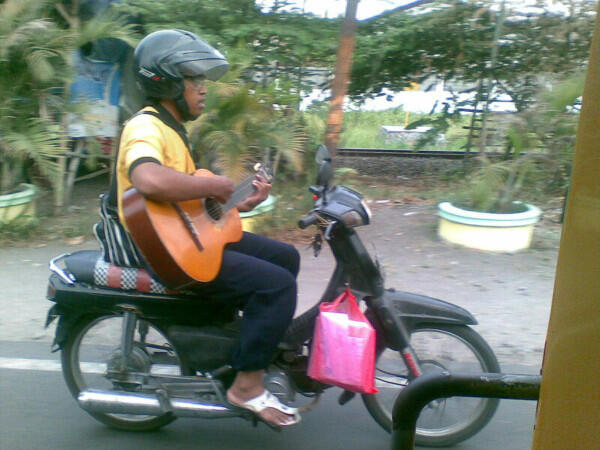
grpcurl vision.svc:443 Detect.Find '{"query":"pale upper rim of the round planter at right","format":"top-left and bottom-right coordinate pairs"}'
top-left (438, 202), bottom-right (542, 227)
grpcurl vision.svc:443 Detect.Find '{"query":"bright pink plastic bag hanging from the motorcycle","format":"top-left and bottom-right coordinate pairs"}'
top-left (308, 288), bottom-right (378, 394)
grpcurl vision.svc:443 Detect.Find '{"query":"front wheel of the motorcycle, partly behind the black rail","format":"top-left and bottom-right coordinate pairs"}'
top-left (362, 324), bottom-right (500, 447)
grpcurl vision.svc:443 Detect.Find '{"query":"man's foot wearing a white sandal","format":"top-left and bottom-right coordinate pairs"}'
top-left (227, 389), bottom-right (300, 427)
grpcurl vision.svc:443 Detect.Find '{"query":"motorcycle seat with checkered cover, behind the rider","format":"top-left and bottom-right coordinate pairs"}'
top-left (64, 250), bottom-right (177, 294)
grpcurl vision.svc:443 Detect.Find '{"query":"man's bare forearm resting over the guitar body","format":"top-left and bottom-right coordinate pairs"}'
top-left (130, 162), bottom-right (234, 203)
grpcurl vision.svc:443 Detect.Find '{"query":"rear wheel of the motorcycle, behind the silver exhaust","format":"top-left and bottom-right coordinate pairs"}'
top-left (61, 314), bottom-right (185, 431)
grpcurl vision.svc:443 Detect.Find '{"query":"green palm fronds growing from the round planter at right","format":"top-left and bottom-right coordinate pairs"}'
top-left (457, 74), bottom-right (585, 212)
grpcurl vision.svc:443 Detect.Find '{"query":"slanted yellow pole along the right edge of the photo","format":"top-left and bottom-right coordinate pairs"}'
top-left (532, 5), bottom-right (600, 450)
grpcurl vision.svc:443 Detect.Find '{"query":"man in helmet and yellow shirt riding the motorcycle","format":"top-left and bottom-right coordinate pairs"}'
top-left (95, 30), bottom-right (300, 426)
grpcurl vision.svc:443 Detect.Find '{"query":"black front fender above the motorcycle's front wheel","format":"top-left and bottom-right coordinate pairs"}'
top-left (383, 289), bottom-right (477, 330)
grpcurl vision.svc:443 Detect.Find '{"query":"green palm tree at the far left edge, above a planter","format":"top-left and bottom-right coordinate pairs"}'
top-left (0, 0), bottom-right (62, 193)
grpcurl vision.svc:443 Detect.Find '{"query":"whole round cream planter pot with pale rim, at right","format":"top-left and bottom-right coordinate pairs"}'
top-left (438, 202), bottom-right (542, 252)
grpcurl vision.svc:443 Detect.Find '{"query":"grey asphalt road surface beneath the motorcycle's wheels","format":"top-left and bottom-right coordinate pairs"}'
top-left (0, 341), bottom-right (535, 450)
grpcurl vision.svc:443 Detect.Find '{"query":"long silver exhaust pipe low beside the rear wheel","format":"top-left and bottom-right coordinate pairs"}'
top-left (77, 389), bottom-right (241, 419)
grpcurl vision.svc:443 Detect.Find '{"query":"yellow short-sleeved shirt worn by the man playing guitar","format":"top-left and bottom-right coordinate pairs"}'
top-left (117, 106), bottom-right (196, 231)
